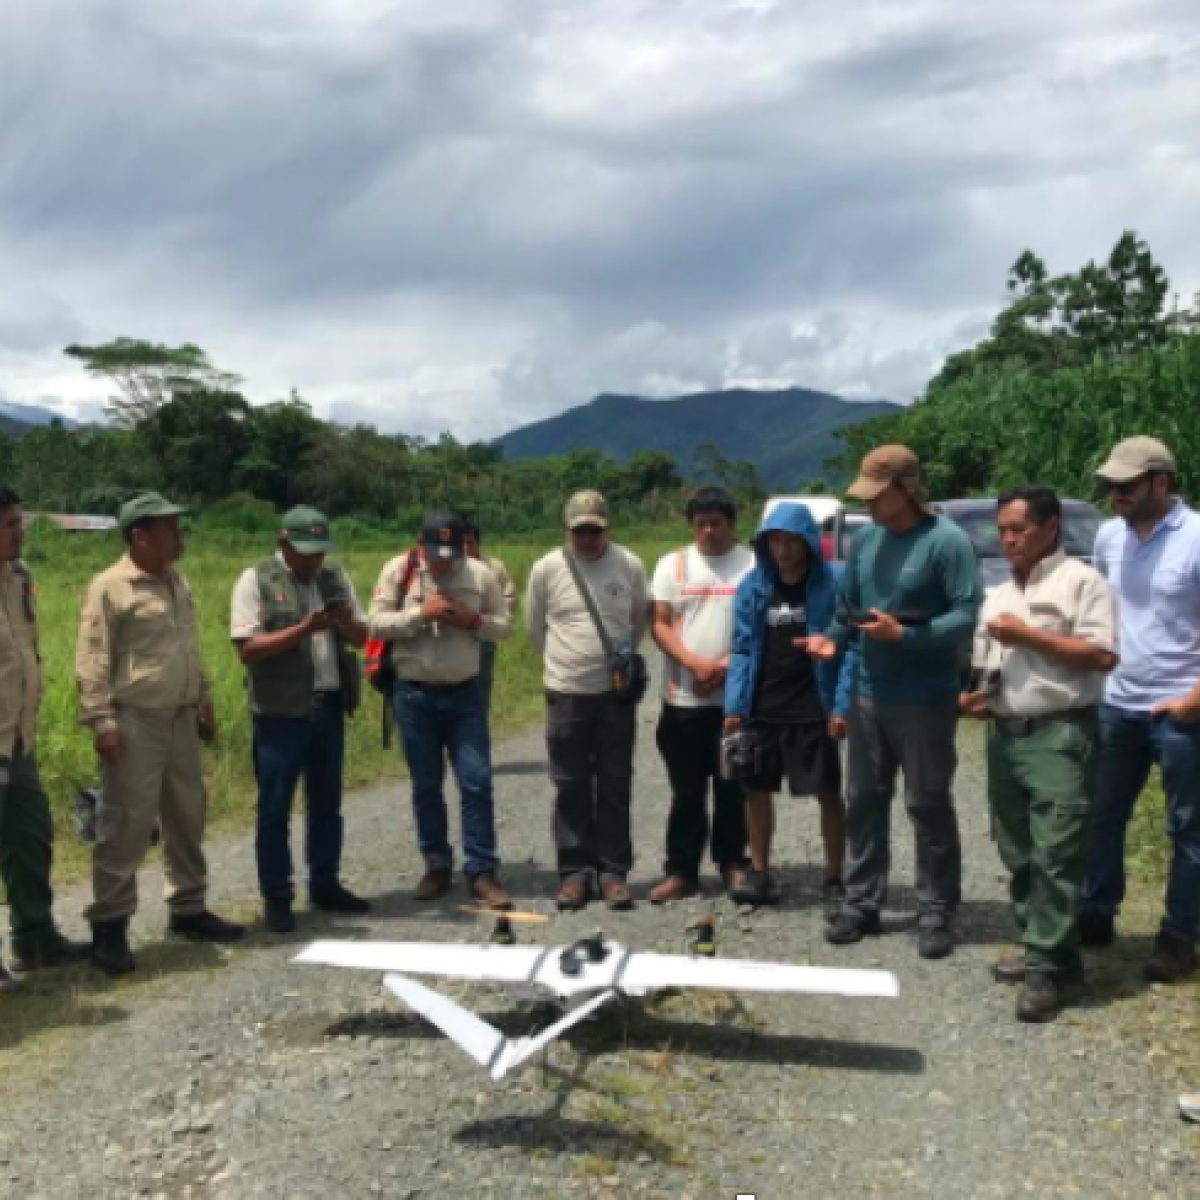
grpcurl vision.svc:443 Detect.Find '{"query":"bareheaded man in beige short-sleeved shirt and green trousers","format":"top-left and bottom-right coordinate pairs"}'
top-left (959, 487), bottom-right (1117, 1021)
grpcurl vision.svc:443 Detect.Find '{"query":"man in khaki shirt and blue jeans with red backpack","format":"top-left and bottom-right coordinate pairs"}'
top-left (367, 512), bottom-right (512, 908)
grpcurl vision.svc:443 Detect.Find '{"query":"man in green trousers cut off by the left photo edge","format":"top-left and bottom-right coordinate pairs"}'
top-left (0, 486), bottom-right (88, 992)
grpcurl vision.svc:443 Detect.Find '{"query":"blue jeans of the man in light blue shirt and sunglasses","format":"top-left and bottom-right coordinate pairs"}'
top-left (1081, 704), bottom-right (1200, 942)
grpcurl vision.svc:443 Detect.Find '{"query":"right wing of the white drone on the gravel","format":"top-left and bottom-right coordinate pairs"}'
top-left (614, 954), bottom-right (900, 998)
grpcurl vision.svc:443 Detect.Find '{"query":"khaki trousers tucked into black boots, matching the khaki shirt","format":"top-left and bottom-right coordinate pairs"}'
top-left (88, 708), bottom-right (208, 924)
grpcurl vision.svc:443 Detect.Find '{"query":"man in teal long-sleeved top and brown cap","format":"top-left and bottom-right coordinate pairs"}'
top-left (806, 445), bottom-right (979, 959)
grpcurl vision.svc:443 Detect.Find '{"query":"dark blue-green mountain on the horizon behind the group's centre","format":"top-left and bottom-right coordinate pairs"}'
top-left (496, 388), bottom-right (900, 488)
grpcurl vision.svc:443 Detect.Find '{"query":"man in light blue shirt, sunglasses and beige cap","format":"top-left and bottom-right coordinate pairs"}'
top-left (1079, 437), bottom-right (1200, 983)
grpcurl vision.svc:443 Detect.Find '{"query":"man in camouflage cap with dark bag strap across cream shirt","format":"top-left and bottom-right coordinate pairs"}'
top-left (526, 491), bottom-right (649, 911)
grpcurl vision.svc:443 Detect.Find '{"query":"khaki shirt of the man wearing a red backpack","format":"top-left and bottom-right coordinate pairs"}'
top-left (367, 554), bottom-right (512, 683)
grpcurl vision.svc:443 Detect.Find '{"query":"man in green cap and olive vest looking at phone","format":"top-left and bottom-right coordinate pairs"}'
top-left (229, 505), bottom-right (371, 934)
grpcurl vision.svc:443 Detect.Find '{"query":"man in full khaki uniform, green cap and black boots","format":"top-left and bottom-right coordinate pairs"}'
top-left (76, 492), bottom-right (245, 974)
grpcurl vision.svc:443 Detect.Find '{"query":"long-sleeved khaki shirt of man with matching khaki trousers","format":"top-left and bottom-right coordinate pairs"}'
top-left (76, 554), bottom-right (209, 733)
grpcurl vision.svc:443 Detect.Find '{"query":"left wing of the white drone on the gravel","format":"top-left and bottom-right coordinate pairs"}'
top-left (292, 942), bottom-right (556, 983)
